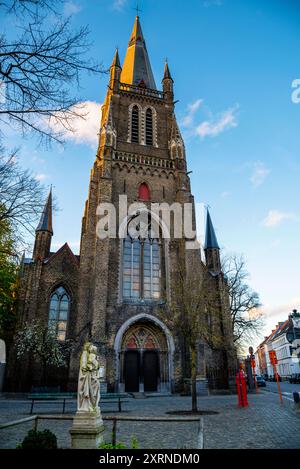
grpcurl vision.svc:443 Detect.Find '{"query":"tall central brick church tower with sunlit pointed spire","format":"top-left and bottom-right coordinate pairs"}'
top-left (69, 16), bottom-right (236, 392)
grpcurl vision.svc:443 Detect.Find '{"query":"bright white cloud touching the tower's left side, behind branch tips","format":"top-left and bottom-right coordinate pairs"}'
top-left (49, 101), bottom-right (101, 148)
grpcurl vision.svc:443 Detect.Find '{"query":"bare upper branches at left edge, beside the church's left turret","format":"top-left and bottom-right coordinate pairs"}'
top-left (0, 147), bottom-right (45, 249)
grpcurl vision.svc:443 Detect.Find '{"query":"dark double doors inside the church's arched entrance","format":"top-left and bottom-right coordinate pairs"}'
top-left (124, 350), bottom-right (159, 392)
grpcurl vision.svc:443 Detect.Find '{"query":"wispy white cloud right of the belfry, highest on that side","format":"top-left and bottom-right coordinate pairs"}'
top-left (196, 105), bottom-right (239, 138)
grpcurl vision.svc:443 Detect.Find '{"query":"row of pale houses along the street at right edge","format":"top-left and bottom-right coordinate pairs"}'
top-left (255, 310), bottom-right (300, 378)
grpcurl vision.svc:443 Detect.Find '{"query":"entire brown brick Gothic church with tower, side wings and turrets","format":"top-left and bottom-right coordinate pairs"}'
top-left (7, 17), bottom-right (235, 393)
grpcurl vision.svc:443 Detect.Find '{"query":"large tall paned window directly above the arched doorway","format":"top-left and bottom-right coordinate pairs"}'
top-left (122, 216), bottom-right (161, 300)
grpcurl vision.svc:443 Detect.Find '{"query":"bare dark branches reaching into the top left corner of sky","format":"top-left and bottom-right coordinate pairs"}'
top-left (0, 0), bottom-right (103, 143)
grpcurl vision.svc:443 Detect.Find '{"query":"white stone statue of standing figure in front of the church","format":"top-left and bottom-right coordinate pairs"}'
top-left (77, 342), bottom-right (100, 414)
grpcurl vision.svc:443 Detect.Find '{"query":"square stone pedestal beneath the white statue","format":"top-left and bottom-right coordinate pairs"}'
top-left (70, 410), bottom-right (104, 449)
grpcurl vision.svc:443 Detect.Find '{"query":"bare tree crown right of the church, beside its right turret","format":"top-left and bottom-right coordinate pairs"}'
top-left (222, 254), bottom-right (264, 346)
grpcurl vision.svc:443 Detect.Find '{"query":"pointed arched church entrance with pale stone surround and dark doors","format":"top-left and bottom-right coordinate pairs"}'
top-left (116, 316), bottom-right (174, 392)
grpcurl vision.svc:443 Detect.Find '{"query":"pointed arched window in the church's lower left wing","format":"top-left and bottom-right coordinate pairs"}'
top-left (48, 287), bottom-right (70, 341)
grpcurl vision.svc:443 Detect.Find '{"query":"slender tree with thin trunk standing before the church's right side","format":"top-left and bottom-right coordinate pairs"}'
top-left (169, 250), bottom-right (225, 412)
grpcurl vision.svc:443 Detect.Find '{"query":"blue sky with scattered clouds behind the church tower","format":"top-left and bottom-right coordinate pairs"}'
top-left (1, 0), bottom-right (300, 345)
